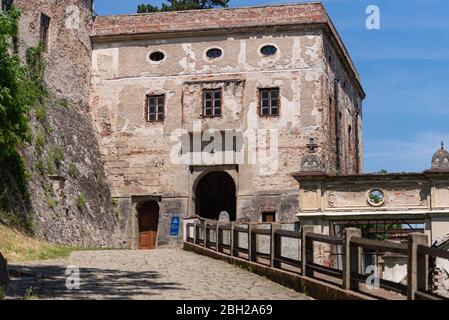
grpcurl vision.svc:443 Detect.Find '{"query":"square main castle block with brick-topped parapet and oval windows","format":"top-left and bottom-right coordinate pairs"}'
top-left (90, 4), bottom-right (365, 248)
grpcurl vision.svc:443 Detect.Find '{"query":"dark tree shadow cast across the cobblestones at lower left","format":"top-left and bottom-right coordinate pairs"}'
top-left (7, 265), bottom-right (187, 300)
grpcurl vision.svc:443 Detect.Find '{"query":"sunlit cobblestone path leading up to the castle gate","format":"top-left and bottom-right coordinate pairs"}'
top-left (7, 249), bottom-right (309, 300)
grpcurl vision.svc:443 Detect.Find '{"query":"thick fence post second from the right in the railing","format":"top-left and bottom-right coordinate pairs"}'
top-left (343, 228), bottom-right (362, 290)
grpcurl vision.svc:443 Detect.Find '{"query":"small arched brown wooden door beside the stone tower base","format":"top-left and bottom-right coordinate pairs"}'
top-left (137, 201), bottom-right (159, 250)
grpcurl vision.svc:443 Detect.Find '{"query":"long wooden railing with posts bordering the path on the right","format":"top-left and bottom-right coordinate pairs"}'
top-left (186, 221), bottom-right (449, 300)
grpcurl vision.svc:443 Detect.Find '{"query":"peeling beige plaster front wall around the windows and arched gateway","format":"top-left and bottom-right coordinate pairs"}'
top-left (92, 31), bottom-right (336, 245)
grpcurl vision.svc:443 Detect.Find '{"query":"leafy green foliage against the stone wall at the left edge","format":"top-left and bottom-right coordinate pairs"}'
top-left (0, 6), bottom-right (46, 231)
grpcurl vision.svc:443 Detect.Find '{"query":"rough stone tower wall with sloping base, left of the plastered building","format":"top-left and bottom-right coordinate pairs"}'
top-left (6, 0), bottom-right (121, 247)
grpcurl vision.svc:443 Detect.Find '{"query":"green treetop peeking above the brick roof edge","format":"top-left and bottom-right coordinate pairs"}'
top-left (137, 0), bottom-right (229, 13)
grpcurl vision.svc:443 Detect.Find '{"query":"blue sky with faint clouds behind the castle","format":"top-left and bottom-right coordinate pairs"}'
top-left (95, 0), bottom-right (449, 172)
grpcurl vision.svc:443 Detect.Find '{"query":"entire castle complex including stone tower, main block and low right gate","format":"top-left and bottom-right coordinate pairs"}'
top-left (6, 0), bottom-right (449, 254)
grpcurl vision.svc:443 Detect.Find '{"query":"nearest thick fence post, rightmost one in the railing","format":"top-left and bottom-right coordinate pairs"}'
top-left (407, 233), bottom-right (429, 300)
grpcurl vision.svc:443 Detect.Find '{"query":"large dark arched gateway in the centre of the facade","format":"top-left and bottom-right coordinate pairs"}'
top-left (195, 171), bottom-right (237, 221)
